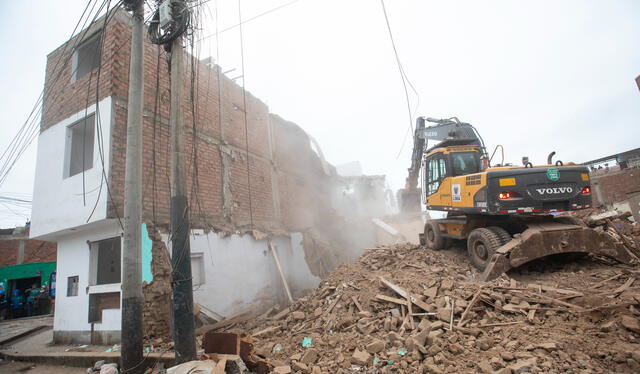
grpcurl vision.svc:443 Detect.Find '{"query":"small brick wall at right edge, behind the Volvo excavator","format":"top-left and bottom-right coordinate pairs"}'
top-left (591, 169), bottom-right (640, 206)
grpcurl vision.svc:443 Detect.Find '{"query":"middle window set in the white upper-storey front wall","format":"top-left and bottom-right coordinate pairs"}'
top-left (65, 113), bottom-right (95, 178)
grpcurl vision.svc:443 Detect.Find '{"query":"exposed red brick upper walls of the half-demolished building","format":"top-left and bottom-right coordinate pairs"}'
top-left (42, 12), bottom-right (335, 234)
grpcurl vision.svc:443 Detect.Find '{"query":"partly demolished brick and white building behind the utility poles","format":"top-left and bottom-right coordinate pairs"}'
top-left (31, 11), bottom-right (378, 344)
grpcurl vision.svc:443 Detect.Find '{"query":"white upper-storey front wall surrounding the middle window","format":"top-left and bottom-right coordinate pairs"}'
top-left (30, 97), bottom-right (112, 238)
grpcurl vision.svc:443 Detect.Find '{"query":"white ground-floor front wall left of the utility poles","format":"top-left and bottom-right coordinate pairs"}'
top-left (53, 220), bottom-right (122, 331)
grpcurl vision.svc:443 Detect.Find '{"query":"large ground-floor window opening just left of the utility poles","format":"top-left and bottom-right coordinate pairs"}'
top-left (90, 236), bottom-right (121, 286)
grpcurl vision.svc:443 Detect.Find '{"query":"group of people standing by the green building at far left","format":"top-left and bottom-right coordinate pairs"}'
top-left (0, 283), bottom-right (55, 319)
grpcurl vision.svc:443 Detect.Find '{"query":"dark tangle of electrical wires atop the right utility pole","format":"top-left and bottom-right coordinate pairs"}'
top-left (148, 0), bottom-right (191, 50)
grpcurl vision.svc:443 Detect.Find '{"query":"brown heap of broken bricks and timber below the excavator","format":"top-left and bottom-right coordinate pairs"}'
top-left (204, 244), bottom-right (640, 373)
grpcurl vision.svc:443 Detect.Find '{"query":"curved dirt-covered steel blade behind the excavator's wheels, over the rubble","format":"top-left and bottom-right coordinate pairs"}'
top-left (480, 222), bottom-right (631, 281)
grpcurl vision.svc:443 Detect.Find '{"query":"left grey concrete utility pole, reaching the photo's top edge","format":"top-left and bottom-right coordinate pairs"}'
top-left (120, 0), bottom-right (145, 374)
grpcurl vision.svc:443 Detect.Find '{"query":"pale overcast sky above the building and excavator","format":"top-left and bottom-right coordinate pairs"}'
top-left (0, 0), bottom-right (640, 227)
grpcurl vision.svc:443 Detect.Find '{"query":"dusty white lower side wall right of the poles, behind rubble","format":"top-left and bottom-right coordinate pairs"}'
top-left (175, 233), bottom-right (320, 316)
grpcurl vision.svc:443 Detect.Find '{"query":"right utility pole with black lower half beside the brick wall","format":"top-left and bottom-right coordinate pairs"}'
top-left (169, 36), bottom-right (196, 363)
